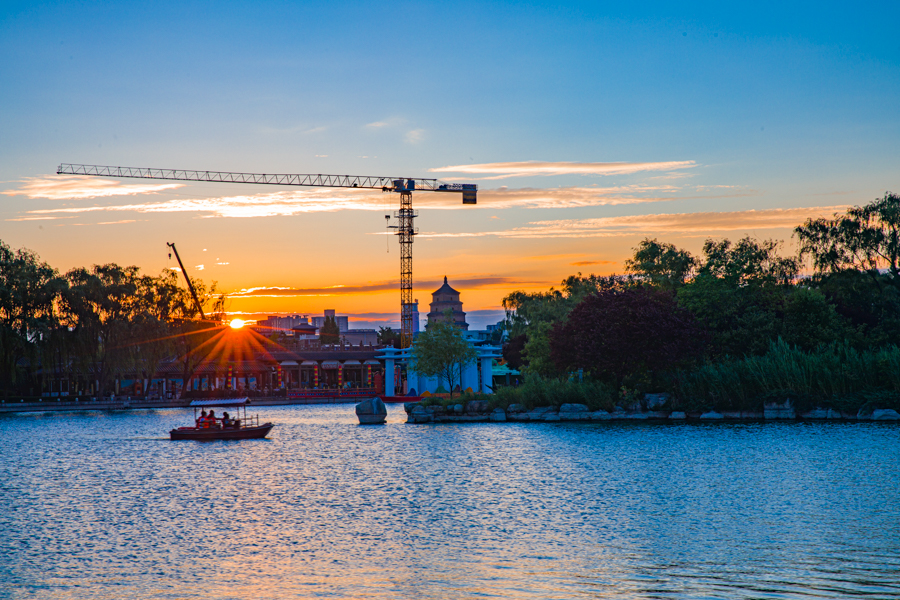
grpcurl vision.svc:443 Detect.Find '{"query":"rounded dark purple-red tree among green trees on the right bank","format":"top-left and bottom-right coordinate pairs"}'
top-left (550, 287), bottom-right (705, 386)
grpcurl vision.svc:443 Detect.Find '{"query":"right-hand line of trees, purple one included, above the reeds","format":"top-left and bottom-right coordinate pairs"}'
top-left (503, 193), bottom-right (900, 386)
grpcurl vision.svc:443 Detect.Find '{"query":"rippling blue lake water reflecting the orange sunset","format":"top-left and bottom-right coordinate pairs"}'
top-left (0, 405), bottom-right (900, 599)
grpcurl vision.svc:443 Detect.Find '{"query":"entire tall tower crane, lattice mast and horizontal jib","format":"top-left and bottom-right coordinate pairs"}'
top-left (56, 163), bottom-right (478, 348)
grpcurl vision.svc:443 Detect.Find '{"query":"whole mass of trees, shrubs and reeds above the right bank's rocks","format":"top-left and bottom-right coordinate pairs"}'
top-left (498, 193), bottom-right (900, 412)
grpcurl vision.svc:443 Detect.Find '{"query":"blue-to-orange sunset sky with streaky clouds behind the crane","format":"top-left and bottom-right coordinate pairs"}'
top-left (0, 1), bottom-right (900, 328)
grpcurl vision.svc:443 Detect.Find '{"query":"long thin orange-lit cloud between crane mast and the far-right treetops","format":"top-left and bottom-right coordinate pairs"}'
top-left (419, 206), bottom-right (847, 239)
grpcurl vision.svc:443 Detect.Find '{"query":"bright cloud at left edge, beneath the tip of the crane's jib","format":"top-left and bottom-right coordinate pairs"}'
top-left (0, 175), bottom-right (185, 200)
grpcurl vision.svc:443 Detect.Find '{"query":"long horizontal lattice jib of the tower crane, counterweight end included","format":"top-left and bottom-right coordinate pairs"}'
top-left (56, 163), bottom-right (478, 204)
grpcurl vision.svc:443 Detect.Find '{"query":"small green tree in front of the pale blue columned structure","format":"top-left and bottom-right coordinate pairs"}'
top-left (412, 321), bottom-right (477, 398)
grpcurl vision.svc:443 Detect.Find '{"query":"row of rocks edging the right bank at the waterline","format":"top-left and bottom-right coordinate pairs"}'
top-left (404, 400), bottom-right (900, 424)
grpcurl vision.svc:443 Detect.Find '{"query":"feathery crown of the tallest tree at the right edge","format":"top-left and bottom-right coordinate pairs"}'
top-left (794, 192), bottom-right (900, 286)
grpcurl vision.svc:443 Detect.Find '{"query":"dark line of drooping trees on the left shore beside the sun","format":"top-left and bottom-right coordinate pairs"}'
top-left (0, 241), bottom-right (222, 396)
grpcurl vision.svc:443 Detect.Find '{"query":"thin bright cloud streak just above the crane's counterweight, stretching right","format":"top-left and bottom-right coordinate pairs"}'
top-left (429, 160), bottom-right (697, 179)
